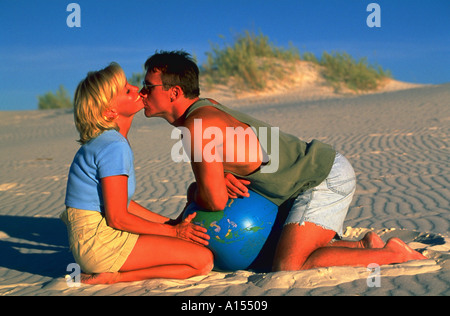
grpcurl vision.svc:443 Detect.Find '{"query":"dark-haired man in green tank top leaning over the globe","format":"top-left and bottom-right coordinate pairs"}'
top-left (141, 51), bottom-right (425, 271)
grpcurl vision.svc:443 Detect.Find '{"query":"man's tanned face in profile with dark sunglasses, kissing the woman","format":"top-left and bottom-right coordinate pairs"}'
top-left (140, 71), bottom-right (170, 117)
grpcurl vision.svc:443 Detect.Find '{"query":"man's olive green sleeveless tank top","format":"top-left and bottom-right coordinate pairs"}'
top-left (185, 99), bottom-right (336, 206)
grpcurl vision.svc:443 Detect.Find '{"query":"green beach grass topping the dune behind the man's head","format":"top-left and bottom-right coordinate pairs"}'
top-left (201, 31), bottom-right (392, 91)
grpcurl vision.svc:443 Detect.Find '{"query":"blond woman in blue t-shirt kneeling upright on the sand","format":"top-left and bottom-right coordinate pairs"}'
top-left (61, 63), bottom-right (213, 284)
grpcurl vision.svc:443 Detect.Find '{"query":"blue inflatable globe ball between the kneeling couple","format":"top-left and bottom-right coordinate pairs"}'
top-left (183, 190), bottom-right (278, 271)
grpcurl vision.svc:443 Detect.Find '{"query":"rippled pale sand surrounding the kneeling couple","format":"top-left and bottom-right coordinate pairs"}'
top-left (0, 84), bottom-right (450, 296)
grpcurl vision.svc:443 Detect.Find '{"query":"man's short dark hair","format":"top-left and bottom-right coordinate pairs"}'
top-left (145, 50), bottom-right (200, 99)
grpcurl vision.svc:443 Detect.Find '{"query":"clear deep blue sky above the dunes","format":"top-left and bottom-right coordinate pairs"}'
top-left (0, 0), bottom-right (450, 110)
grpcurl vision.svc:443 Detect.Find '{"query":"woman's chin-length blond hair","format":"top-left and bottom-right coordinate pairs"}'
top-left (73, 62), bottom-right (127, 144)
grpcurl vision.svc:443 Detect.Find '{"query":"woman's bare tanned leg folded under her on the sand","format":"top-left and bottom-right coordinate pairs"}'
top-left (81, 235), bottom-right (213, 284)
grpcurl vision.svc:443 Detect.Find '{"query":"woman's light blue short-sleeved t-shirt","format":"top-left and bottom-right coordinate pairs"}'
top-left (65, 130), bottom-right (136, 212)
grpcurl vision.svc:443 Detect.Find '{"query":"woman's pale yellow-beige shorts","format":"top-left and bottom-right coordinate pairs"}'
top-left (60, 208), bottom-right (139, 273)
